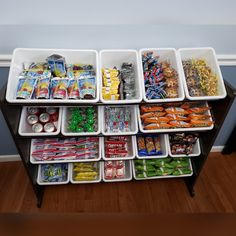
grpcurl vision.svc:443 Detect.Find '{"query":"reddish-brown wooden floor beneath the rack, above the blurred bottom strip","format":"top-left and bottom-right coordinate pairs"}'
top-left (0, 153), bottom-right (236, 213)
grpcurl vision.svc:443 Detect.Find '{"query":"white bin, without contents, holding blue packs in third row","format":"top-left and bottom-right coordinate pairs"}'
top-left (135, 134), bottom-right (168, 159)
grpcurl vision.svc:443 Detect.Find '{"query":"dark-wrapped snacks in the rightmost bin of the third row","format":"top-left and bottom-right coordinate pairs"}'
top-left (169, 133), bottom-right (198, 155)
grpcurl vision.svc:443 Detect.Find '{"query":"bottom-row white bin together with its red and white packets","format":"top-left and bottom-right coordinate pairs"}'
top-left (102, 161), bottom-right (132, 182)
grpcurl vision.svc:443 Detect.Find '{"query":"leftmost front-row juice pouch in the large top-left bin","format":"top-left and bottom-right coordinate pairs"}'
top-left (16, 78), bottom-right (37, 99)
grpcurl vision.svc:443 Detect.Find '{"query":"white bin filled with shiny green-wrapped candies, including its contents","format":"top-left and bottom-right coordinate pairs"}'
top-left (61, 106), bottom-right (101, 136)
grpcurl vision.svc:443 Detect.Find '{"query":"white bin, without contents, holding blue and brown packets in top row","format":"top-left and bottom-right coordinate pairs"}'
top-left (139, 48), bottom-right (185, 103)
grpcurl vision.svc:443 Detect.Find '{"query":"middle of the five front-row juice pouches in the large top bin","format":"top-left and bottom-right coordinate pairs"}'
top-left (51, 78), bottom-right (68, 99)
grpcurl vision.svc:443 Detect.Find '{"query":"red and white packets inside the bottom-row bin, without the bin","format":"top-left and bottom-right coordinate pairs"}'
top-left (104, 161), bottom-right (125, 180)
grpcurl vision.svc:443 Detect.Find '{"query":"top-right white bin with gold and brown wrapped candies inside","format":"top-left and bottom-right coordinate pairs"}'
top-left (179, 48), bottom-right (226, 100)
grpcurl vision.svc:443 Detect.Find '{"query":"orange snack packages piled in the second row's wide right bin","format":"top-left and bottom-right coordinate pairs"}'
top-left (140, 102), bottom-right (213, 130)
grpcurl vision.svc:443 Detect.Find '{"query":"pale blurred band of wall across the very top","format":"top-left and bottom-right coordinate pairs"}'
top-left (0, 0), bottom-right (236, 25)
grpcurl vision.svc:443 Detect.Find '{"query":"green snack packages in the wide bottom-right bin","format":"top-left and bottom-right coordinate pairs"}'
top-left (134, 158), bottom-right (192, 179)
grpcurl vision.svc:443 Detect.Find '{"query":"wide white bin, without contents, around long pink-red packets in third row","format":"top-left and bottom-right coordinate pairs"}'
top-left (30, 138), bottom-right (102, 164)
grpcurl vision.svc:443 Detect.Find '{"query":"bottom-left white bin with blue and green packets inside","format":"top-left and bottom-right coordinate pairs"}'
top-left (37, 163), bottom-right (69, 185)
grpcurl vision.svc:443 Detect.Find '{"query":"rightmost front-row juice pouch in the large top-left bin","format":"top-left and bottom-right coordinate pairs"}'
top-left (78, 77), bottom-right (96, 99)
